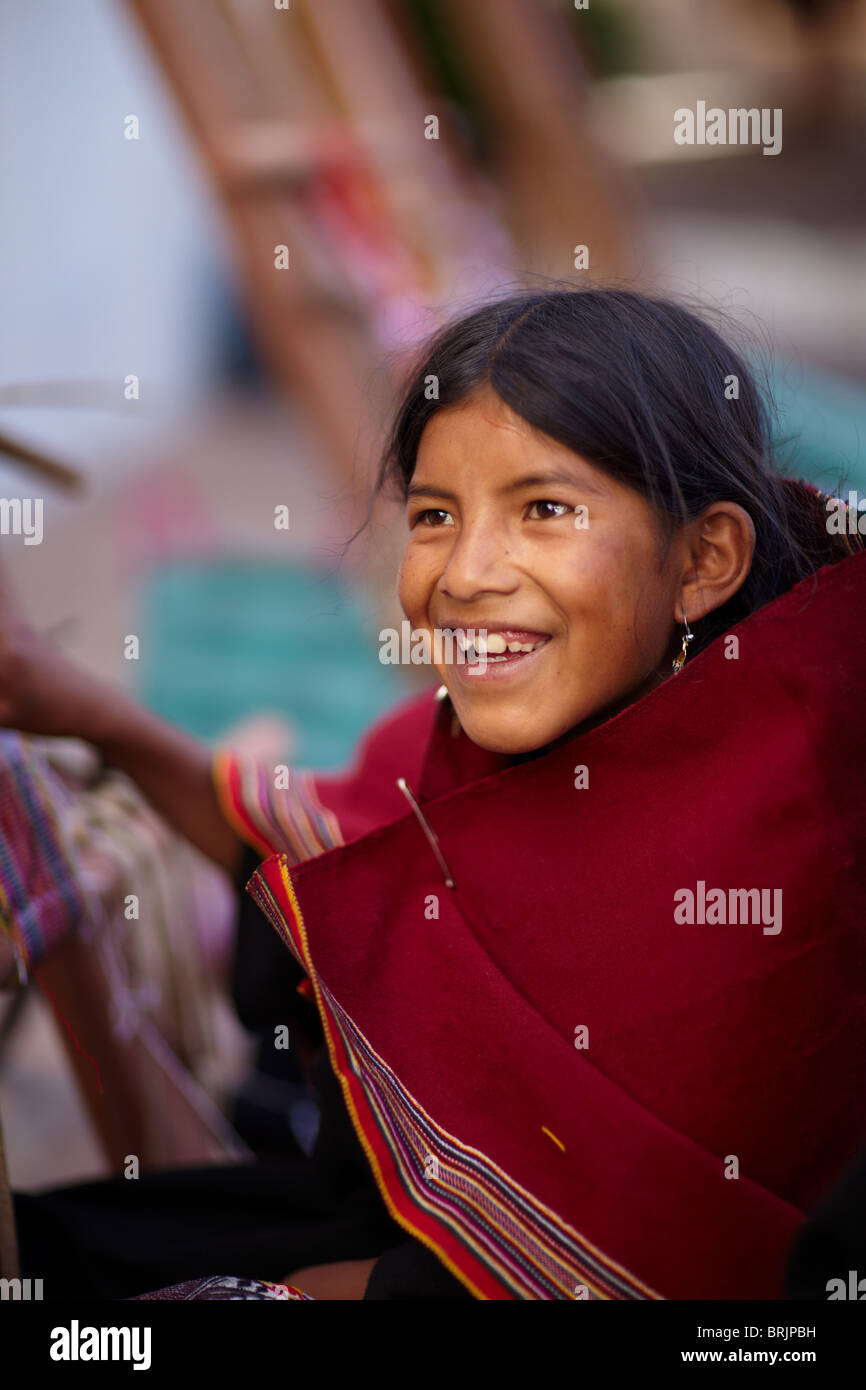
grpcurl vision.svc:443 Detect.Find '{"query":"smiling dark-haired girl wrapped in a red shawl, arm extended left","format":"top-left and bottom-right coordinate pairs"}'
top-left (0, 291), bottom-right (866, 1298)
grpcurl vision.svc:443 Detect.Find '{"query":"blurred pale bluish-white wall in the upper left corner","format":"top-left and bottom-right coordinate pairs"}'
top-left (0, 0), bottom-right (233, 495)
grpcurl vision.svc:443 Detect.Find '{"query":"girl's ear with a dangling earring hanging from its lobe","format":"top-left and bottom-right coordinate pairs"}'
top-left (676, 502), bottom-right (755, 623)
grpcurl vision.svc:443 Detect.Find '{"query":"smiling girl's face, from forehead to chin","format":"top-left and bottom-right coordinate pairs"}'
top-left (399, 388), bottom-right (688, 753)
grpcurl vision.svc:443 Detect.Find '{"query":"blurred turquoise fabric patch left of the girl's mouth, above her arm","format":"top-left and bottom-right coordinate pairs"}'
top-left (139, 560), bottom-right (409, 770)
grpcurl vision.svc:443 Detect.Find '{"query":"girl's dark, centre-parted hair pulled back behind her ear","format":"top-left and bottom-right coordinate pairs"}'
top-left (377, 289), bottom-right (862, 655)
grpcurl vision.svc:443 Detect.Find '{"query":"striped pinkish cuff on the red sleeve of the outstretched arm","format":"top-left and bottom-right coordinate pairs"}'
top-left (211, 752), bottom-right (343, 863)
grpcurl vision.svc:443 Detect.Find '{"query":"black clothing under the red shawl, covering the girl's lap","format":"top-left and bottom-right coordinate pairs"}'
top-left (13, 851), bottom-right (471, 1300)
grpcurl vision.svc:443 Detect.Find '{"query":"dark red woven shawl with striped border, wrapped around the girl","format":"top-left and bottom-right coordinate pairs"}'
top-left (217, 553), bottom-right (866, 1298)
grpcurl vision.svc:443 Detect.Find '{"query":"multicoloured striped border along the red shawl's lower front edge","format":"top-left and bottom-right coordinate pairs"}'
top-left (253, 860), bottom-right (660, 1300)
